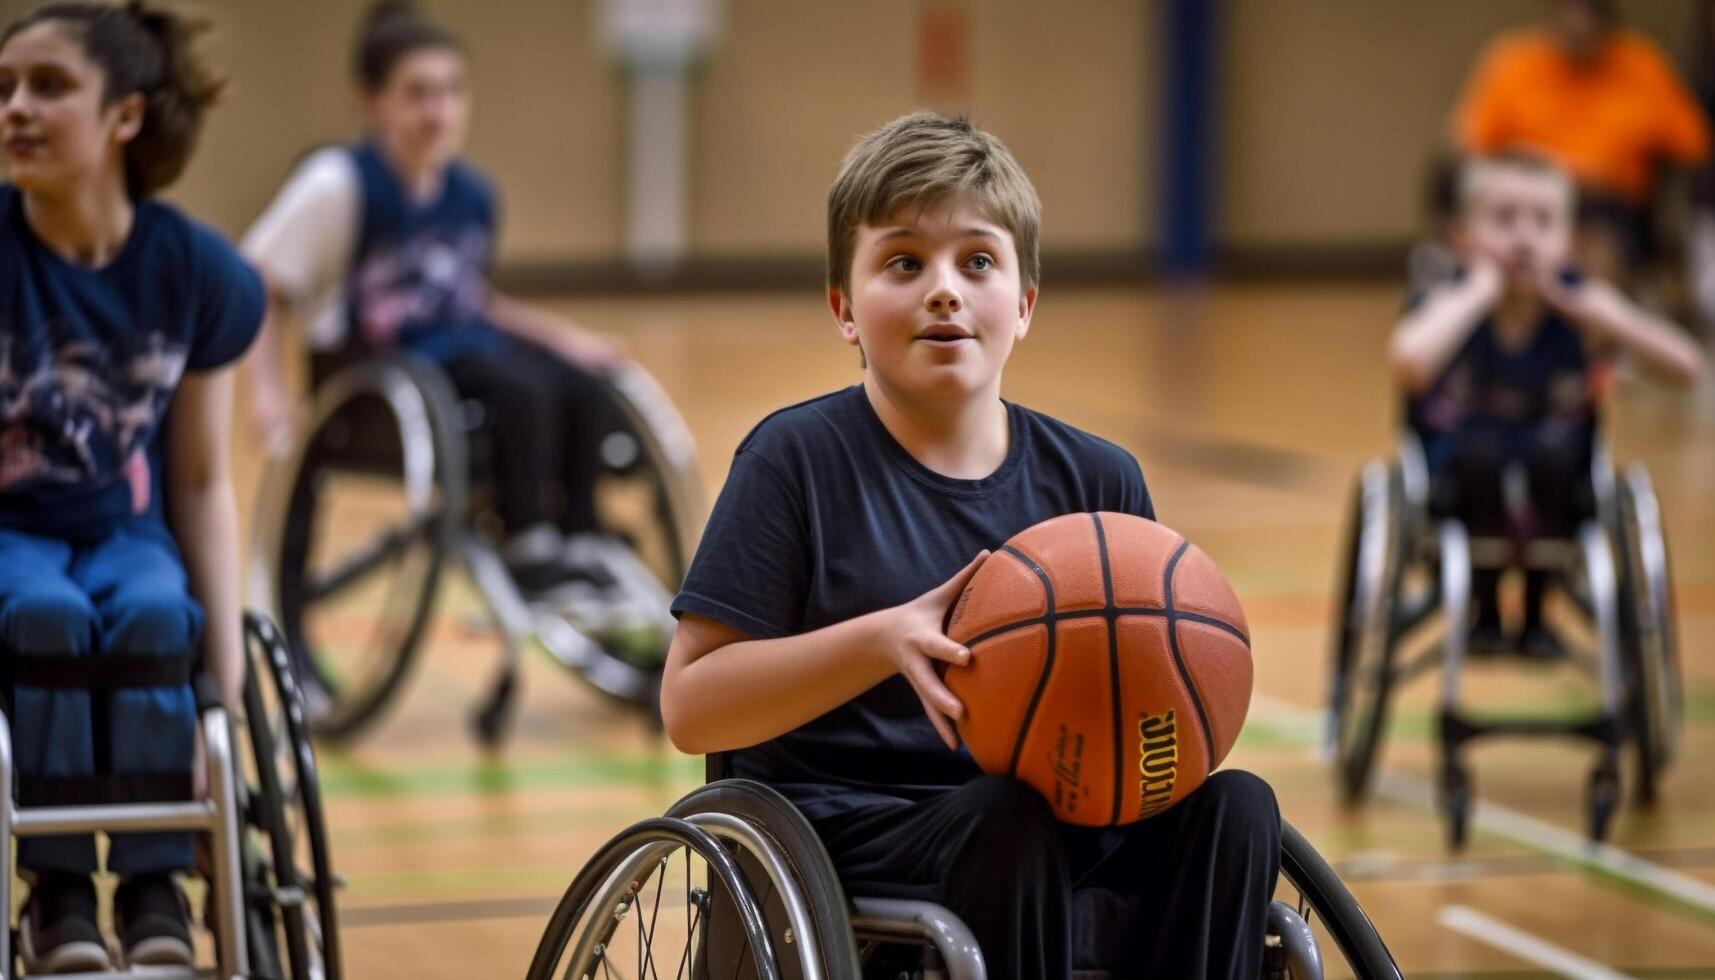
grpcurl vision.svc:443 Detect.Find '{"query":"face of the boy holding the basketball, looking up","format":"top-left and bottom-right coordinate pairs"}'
top-left (828, 197), bottom-right (1036, 400)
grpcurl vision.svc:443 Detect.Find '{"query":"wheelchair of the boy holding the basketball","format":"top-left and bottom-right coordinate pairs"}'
top-left (527, 755), bottom-right (1401, 980)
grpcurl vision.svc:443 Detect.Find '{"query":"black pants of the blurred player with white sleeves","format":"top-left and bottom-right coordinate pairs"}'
top-left (444, 336), bottom-right (619, 534)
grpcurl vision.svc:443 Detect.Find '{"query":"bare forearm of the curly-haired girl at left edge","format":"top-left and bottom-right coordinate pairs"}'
top-left (172, 479), bottom-right (244, 705)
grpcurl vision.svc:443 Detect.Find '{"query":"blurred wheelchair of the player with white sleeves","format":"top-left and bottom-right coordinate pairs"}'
top-left (252, 350), bottom-right (703, 747)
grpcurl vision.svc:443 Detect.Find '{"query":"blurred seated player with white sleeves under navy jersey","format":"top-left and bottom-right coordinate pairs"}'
top-left (242, 0), bottom-right (644, 594)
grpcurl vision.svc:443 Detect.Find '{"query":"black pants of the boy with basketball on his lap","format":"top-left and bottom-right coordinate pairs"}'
top-left (816, 771), bottom-right (1279, 980)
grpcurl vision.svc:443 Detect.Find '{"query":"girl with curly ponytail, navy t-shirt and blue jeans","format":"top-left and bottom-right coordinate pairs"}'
top-left (0, 3), bottom-right (264, 973)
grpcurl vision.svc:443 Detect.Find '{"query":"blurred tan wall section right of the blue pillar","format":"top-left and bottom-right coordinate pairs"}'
top-left (1218, 0), bottom-right (1693, 247)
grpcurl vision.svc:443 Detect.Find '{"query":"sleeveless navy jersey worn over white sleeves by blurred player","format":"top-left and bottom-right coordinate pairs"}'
top-left (346, 142), bottom-right (502, 362)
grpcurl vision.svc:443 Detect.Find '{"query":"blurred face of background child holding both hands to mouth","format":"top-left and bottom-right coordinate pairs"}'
top-left (1463, 166), bottom-right (1573, 283)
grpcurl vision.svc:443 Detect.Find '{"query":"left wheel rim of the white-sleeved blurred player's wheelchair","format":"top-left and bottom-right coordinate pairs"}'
top-left (254, 354), bottom-right (468, 740)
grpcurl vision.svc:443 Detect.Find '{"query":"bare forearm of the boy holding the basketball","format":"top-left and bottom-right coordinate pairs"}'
top-left (662, 611), bottom-right (894, 753)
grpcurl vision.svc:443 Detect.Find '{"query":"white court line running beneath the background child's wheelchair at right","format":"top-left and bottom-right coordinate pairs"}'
top-left (1252, 695), bottom-right (1715, 915)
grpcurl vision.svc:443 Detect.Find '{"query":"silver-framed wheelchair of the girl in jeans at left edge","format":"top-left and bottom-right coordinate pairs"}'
top-left (0, 613), bottom-right (341, 980)
